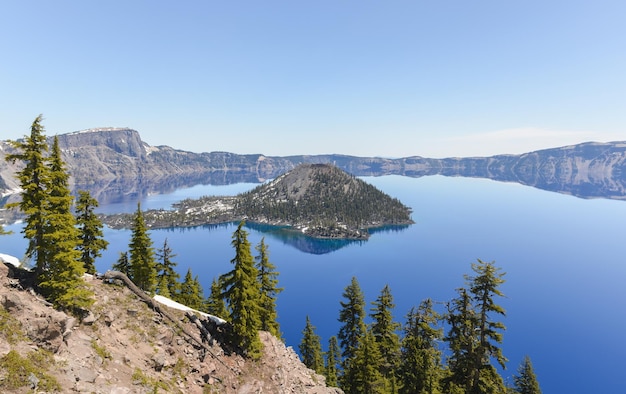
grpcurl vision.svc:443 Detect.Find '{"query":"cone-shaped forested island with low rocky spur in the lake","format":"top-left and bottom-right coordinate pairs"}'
top-left (101, 164), bottom-right (413, 239)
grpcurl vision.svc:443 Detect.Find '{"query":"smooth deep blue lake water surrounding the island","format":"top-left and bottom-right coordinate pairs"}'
top-left (0, 176), bottom-right (626, 393)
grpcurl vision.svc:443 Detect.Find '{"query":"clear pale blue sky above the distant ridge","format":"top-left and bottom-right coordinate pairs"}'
top-left (0, 0), bottom-right (626, 157)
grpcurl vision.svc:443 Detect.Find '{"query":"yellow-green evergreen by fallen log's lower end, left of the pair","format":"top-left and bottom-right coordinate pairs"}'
top-left (221, 221), bottom-right (263, 359)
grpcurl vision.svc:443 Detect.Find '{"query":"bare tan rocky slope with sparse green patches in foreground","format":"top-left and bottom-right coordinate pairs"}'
top-left (0, 263), bottom-right (341, 394)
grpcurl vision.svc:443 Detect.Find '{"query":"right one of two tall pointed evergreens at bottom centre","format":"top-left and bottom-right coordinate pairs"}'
top-left (370, 285), bottom-right (400, 393)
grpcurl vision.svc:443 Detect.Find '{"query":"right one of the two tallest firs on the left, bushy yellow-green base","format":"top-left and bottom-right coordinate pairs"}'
top-left (39, 136), bottom-right (94, 313)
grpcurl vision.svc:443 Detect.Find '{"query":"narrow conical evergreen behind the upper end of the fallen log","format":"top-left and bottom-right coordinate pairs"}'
top-left (129, 203), bottom-right (156, 294)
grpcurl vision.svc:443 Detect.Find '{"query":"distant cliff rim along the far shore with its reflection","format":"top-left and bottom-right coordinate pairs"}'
top-left (0, 128), bottom-right (626, 202)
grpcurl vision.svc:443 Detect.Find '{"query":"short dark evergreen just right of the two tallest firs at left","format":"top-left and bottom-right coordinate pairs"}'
top-left (76, 190), bottom-right (109, 274)
